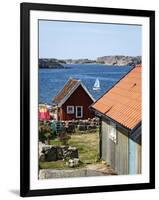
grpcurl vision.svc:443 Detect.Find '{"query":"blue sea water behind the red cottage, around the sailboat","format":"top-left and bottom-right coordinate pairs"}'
top-left (39, 64), bottom-right (131, 104)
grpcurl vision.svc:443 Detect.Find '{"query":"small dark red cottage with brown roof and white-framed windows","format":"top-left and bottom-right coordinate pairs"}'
top-left (53, 78), bottom-right (94, 120)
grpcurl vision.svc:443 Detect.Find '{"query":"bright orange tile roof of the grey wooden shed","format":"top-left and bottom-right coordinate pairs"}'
top-left (91, 65), bottom-right (142, 129)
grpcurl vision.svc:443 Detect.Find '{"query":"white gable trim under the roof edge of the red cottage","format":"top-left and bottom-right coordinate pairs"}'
top-left (58, 80), bottom-right (95, 107)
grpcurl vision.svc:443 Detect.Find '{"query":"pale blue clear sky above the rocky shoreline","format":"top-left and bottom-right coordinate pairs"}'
top-left (39, 20), bottom-right (142, 59)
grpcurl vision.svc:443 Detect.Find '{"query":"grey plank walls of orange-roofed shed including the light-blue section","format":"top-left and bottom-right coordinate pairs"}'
top-left (100, 118), bottom-right (142, 174)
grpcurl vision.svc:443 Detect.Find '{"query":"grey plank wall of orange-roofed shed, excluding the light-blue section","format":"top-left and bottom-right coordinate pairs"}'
top-left (101, 119), bottom-right (128, 174)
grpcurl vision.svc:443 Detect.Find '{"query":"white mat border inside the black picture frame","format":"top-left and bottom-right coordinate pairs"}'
top-left (30, 11), bottom-right (150, 190)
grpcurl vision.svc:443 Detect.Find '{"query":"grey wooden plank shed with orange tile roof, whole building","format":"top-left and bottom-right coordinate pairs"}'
top-left (91, 65), bottom-right (142, 174)
